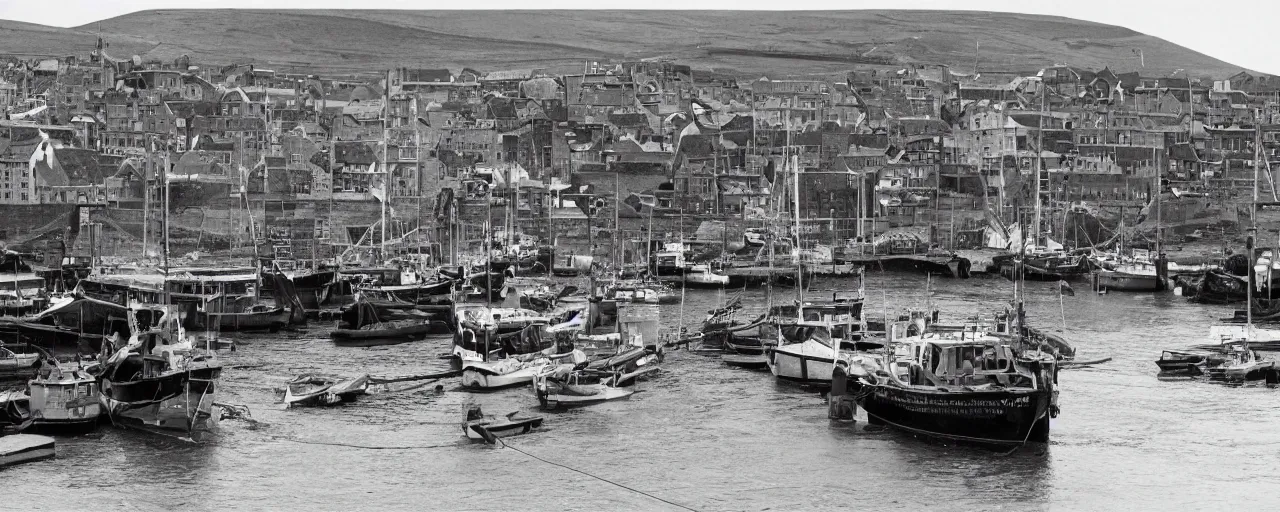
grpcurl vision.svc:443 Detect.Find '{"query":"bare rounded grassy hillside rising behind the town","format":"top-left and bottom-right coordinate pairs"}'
top-left (0, 10), bottom-right (1242, 77)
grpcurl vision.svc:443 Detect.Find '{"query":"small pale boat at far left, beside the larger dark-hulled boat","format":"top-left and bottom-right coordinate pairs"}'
top-left (27, 361), bottom-right (102, 433)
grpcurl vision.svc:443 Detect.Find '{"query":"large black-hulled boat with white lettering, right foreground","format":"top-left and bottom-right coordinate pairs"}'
top-left (846, 320), bottom-right (1057, 445)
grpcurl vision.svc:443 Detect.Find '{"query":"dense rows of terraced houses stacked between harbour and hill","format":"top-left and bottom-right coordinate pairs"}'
top-left (0, 41), bottom-right (1280, 257)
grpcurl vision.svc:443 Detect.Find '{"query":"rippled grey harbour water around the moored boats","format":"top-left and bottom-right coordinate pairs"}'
top-left (0, 271), bottom-right (1280, 511)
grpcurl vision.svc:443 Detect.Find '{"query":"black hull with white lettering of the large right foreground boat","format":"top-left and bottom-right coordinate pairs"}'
top-left (855, 384), bottom-right (1051, 445)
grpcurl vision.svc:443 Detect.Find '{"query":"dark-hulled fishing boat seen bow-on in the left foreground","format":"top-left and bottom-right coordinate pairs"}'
top-left (97, 303), bottom-right (223, 442)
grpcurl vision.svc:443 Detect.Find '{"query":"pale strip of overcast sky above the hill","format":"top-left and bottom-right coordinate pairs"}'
top-left (0, 0), bottom-right (1280, 74)
